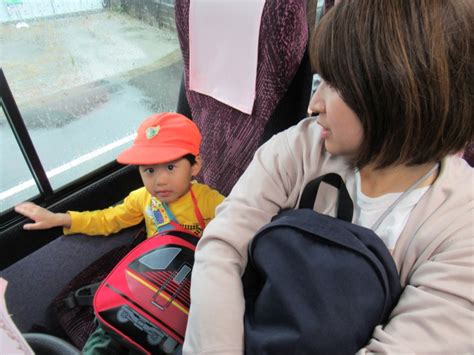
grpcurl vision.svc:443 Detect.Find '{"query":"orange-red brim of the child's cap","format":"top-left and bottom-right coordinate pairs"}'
top-left (117, 146), bottom-right (199, 165)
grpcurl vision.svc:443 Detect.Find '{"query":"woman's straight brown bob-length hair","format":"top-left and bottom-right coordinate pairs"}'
top-left (310, 0), bottom-right (474, 168)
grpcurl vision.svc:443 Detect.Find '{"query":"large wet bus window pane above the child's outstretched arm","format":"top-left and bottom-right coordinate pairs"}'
top-left (0, 0), bottom-right (183, 195)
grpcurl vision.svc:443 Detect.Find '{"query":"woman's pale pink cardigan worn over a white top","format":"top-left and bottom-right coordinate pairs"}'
top-left (184, 118), bottom-right (474, 355)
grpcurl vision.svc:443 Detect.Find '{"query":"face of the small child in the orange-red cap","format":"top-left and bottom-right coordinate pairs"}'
top-left (139, 157), bottom-right (201, 203)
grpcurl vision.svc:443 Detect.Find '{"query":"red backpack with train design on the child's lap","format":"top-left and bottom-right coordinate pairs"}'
top-left (93, 226), bottom-right (199, 353)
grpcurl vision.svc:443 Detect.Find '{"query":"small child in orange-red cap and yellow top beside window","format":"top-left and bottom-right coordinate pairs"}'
top-left (15, 113), bottom-right (224, 353)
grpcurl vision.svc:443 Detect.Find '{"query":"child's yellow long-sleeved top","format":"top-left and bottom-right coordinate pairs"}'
top-left (63, 183), bottom-right (224, 237)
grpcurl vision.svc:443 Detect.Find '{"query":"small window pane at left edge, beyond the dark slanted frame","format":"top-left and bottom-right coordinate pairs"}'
top-left (0, 106), bottom-right (39, 213)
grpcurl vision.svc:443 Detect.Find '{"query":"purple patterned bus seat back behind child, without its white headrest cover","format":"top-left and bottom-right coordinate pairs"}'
top-left (175, 0), bottom-right (312, 195)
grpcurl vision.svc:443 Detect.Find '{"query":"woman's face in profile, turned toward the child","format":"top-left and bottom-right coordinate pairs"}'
top-left (309, 81), bottom-right (364, 156)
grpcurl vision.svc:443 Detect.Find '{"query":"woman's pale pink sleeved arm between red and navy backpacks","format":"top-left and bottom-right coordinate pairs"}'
top-left (184, 134), bottom-right (301, 354)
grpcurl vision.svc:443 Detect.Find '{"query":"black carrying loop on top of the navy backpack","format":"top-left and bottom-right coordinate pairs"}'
top-left (298, 173), bottom-right (354, 223)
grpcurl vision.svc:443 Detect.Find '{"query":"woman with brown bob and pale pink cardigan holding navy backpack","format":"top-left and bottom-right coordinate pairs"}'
top-left (184, 0), bottom-right (474, 354)
